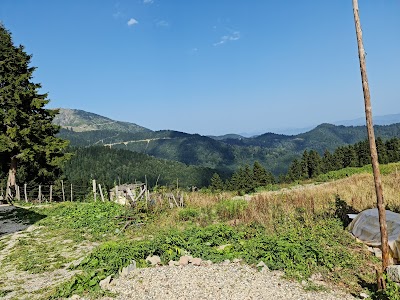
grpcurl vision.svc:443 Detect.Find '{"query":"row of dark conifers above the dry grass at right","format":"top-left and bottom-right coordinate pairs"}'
top-left (209, 137), bottom-right (400, 194)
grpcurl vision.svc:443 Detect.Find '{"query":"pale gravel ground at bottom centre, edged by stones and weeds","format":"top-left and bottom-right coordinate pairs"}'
top-left (103, 263), bottom-right (355, 300)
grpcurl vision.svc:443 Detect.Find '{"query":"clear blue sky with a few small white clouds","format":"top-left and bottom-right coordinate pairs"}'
top-left (0, 0), bottom-right (400, 134)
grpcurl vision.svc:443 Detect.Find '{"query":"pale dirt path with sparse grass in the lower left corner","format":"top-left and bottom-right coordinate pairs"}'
top-left (0, 205), bottom-right (96, 300)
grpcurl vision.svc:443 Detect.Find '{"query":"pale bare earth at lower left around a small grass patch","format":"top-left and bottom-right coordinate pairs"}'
top-left (0, 211), bottom-right (96, 300)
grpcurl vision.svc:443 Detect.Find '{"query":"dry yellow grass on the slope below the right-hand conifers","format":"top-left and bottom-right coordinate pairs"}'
top-left (187, 173), bottom-right (400, 227)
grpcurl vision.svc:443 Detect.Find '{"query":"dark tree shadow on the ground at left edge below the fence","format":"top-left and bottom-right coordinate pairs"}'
top-left (0, 205), bottom-right (46, 237)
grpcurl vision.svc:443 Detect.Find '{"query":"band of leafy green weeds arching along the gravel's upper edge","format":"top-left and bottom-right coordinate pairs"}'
top-left (57, 218), bottom-right (372, 297)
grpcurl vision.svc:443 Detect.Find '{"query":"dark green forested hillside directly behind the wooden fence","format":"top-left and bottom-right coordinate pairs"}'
top-left (64, 146), bottom-right (215, 187)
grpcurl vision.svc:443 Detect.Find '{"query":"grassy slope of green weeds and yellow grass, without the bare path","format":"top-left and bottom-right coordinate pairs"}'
top-left (0, 164), bottom-right (400, 296)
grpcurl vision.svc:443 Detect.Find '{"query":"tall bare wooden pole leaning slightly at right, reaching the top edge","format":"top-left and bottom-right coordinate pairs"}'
top-left (353, 0), bottom-right (389, 278)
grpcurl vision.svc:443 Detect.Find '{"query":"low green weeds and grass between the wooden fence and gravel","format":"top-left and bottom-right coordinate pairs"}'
top-left (0, 168), bottom-right (398, 299)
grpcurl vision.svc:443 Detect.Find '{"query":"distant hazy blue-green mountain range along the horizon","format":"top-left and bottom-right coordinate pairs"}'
top-left (54, 109), bottom-right (400, 175)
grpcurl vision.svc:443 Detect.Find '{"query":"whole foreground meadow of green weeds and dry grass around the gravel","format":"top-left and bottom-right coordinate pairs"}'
top-left (0, 164), bottom-right (400, 299)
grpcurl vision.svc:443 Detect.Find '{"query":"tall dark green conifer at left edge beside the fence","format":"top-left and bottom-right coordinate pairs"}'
top-left (0, 23), bottom-right (67, 197)
